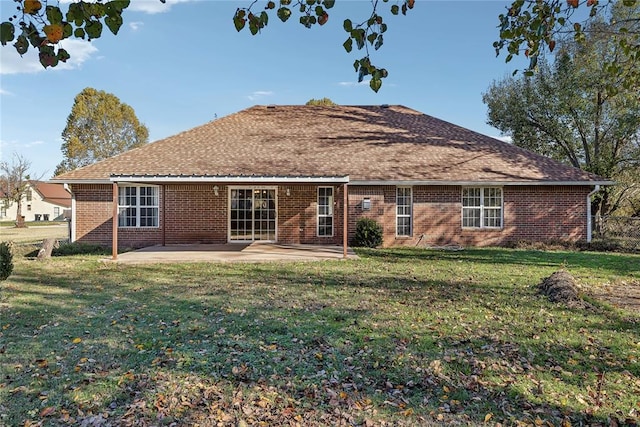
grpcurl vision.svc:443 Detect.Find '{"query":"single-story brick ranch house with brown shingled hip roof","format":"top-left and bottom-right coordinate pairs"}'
top-left (53, 105), bottom-right (611, 257)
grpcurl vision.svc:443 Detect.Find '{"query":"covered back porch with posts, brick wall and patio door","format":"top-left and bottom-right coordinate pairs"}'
top-left (105, 175), bottom-right (349, 260)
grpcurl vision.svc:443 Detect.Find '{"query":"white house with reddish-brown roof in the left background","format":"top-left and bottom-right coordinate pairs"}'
top-left (0, 181), bottom-right (71, 221)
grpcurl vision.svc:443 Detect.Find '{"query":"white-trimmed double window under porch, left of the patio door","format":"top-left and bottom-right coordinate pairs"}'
top-left (118, 185), bottom-right (160, 227)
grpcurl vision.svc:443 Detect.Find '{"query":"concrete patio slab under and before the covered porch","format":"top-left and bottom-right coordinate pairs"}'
top-left (104, 243), bottom-right (358, 264)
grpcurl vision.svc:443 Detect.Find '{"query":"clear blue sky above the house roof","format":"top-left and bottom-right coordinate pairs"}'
top-left (0, 0), bottom-right (523, 178)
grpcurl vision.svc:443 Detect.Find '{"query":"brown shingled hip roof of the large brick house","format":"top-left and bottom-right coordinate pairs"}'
top-left (54, 105), bottom-right (606, 184)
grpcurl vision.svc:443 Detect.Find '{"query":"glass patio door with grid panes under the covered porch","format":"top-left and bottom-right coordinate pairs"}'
top-left (229, 188), bottom-right (276, 242)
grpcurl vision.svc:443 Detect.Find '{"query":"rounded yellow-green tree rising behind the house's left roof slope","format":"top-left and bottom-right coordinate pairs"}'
top-left (55, 88), bottom-right (149, 175)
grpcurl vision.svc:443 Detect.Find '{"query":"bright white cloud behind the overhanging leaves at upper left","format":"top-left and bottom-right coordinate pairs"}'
top-left (0, 40), bottom-right (98, 74)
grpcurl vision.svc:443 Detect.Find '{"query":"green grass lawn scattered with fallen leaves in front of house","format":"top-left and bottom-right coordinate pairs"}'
top-left (0, 249), bottom-right (640, 426)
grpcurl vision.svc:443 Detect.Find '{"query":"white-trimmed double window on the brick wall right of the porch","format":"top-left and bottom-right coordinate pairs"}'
top-left (462, 187), bottom-right (502, 228)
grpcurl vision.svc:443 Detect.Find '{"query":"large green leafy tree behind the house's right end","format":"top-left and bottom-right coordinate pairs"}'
top-left (483, 9), bottom-right (640, 213)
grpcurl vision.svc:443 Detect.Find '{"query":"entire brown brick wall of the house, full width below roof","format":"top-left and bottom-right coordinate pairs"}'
top-left (72, 184), bottom-right (590, 247)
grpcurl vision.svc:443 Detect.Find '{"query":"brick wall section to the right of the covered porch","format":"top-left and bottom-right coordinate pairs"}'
top-left (349, 186), bottom-right (590, 246)
